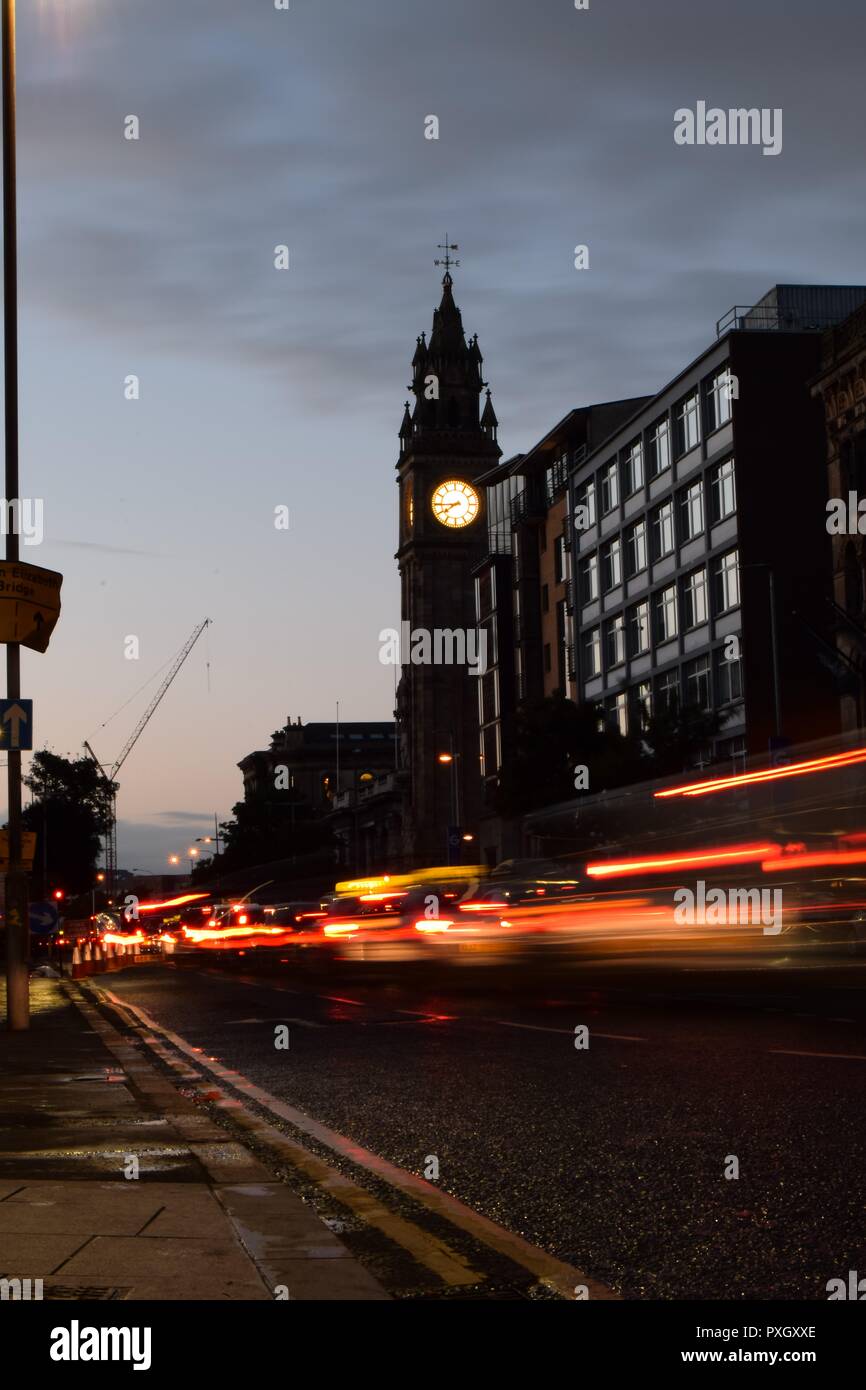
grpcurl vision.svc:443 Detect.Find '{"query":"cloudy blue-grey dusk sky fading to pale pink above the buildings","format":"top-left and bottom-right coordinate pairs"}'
top-left (6, 0), bottom-right (866, 870)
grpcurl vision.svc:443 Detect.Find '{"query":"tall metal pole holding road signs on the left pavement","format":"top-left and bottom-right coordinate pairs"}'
top-left (1, 0), bottom-right (31, 1030)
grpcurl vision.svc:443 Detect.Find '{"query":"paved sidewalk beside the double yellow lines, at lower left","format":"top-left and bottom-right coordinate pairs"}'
top-left (0, 980), bottom-right (388, 1300)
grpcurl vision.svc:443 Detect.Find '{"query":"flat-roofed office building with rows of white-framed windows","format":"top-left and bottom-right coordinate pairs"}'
top-left (567, 285), bottom-right (866, 766)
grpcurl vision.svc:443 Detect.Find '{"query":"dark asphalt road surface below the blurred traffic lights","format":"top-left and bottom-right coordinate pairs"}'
top-left (99, 952), bottom-right (866, 1300)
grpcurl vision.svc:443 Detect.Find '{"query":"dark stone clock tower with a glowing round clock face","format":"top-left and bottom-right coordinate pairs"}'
top-left (396, 265), bottom-right (502, 866)
